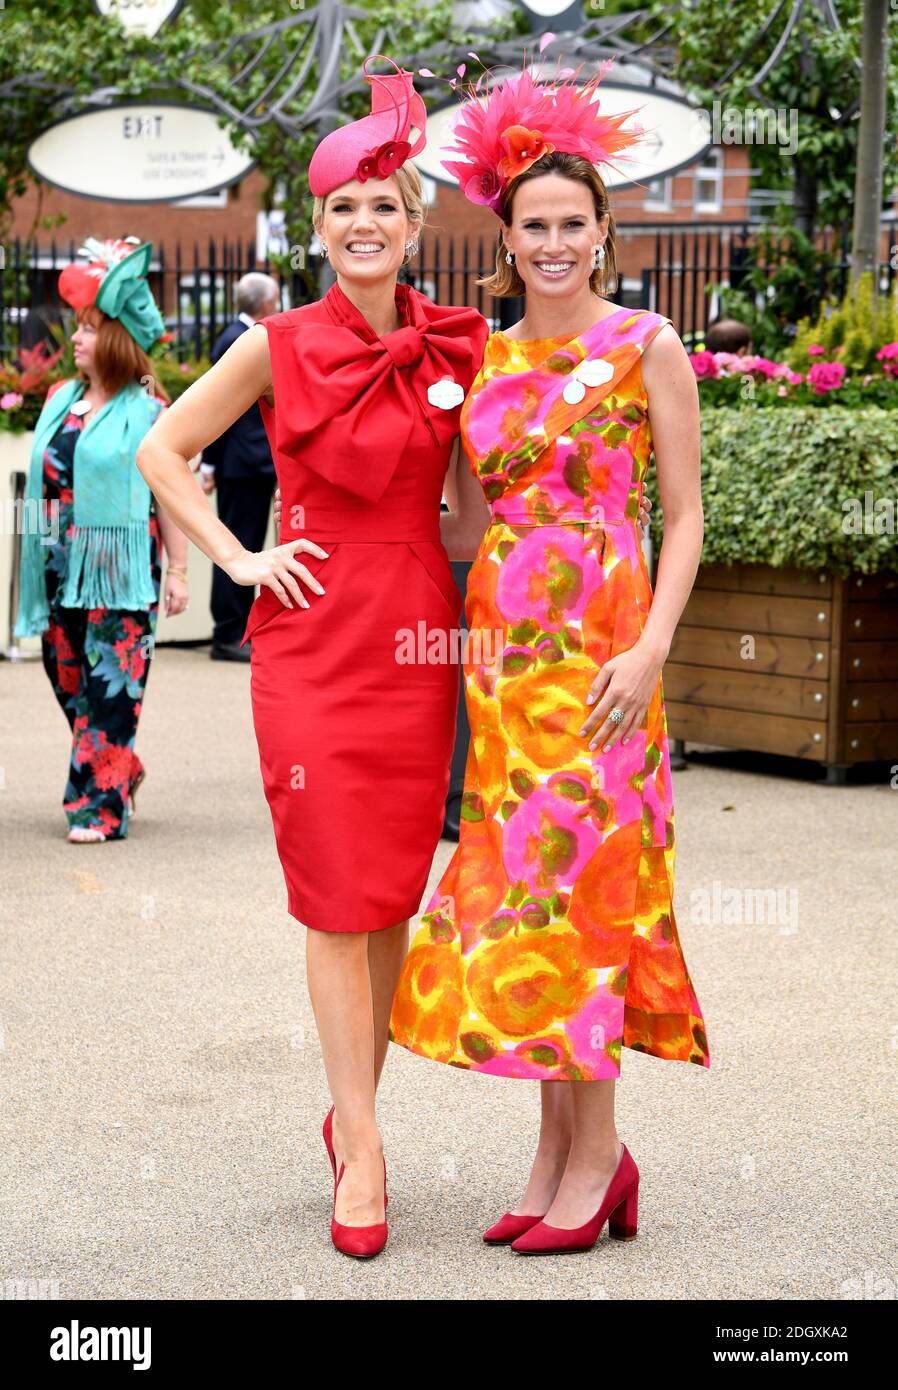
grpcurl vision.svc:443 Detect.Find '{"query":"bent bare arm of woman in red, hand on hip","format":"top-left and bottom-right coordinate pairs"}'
top-left (138, 324), bottom-right (327, 607)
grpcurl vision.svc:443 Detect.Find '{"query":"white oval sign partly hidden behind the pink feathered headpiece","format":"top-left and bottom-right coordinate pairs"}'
top-left (414, 68), bottom-right (710, 188)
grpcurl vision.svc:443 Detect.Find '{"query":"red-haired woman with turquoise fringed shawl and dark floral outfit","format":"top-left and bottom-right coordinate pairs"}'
top-left (15, 239), bottom-right (186, 844)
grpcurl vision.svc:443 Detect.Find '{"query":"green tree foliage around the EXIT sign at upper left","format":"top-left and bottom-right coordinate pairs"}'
top-left (0, 0), bottom-right (519, 258)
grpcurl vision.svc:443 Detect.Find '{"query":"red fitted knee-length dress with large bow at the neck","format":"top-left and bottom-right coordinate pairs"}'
top-left (243, 285), bottom-right (488, 931)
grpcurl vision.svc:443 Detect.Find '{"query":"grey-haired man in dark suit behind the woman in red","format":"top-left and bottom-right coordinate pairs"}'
top-left (200, 271), bottom-right (279, 662)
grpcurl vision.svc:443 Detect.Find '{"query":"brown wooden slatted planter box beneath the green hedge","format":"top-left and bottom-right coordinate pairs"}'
top-left (663, 564), bottom-right (898, 783)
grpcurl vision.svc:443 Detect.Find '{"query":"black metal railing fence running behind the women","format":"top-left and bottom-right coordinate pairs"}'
top-left (0, 221), bottom-right (897, 357)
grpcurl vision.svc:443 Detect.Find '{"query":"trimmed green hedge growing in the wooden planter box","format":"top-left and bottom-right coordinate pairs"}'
top-left (646, 406), bottom-right (898, 575)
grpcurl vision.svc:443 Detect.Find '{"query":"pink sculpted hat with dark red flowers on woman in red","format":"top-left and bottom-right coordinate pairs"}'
top-left (309, 53), bottom-right (427, 197)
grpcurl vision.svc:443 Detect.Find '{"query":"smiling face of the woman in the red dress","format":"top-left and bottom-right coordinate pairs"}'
top-left (316, 175), bottom-right (414, 284)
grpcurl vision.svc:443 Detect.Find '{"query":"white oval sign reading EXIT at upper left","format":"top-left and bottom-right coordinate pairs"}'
top-left (26, 101), bottom-right (256, 203)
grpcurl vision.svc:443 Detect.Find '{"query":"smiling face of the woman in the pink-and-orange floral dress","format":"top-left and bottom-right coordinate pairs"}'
top-left (503, 174), bottom-right (609, 296)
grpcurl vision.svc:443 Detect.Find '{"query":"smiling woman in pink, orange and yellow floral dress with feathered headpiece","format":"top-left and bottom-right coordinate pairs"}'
top-left (391, 72), bottom-right (709, 1254)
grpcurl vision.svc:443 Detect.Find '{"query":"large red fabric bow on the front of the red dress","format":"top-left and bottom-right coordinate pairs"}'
top-left (268, 285), bottom-right (489, 502)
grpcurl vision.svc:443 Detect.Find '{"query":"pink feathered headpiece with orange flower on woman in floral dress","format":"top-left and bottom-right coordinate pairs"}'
top-left (441, 58), bottom-right (645, 217)
